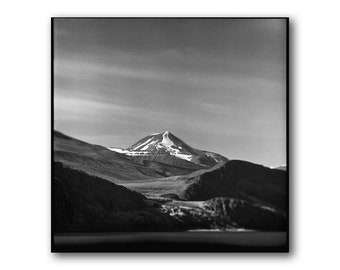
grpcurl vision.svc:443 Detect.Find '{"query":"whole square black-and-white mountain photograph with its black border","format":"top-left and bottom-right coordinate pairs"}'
top-left (51, 17), bottom-right (289, 252)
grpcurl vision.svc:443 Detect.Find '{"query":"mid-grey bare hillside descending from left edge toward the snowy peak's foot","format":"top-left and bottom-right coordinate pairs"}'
top-left (54, 131), bottom-right (205, 182)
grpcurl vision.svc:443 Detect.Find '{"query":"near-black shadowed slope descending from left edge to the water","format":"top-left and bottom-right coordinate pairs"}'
top-left (52, 162), bottom-right (178, 232)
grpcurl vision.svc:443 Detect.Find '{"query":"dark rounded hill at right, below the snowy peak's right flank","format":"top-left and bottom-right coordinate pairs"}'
top-left (179, 160), bottom-right (287, 210)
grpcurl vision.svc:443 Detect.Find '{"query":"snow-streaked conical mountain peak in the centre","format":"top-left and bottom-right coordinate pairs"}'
top-left (108, 131), bottom-right (228, 170)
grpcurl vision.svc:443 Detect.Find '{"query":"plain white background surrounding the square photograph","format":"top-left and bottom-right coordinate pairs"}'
top-left (0, 0), bottom-right (340, 270)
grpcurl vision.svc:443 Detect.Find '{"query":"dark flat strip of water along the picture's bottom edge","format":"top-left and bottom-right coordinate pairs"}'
top-left (52, 231), bottom-right (288, 252)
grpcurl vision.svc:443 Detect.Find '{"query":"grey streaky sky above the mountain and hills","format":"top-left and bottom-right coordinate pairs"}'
top-left (53, 19), bottom-right (286, 166)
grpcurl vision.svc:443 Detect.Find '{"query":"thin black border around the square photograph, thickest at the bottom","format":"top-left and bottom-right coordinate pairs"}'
top-left (50, 17), bottom-right (290, 253)
